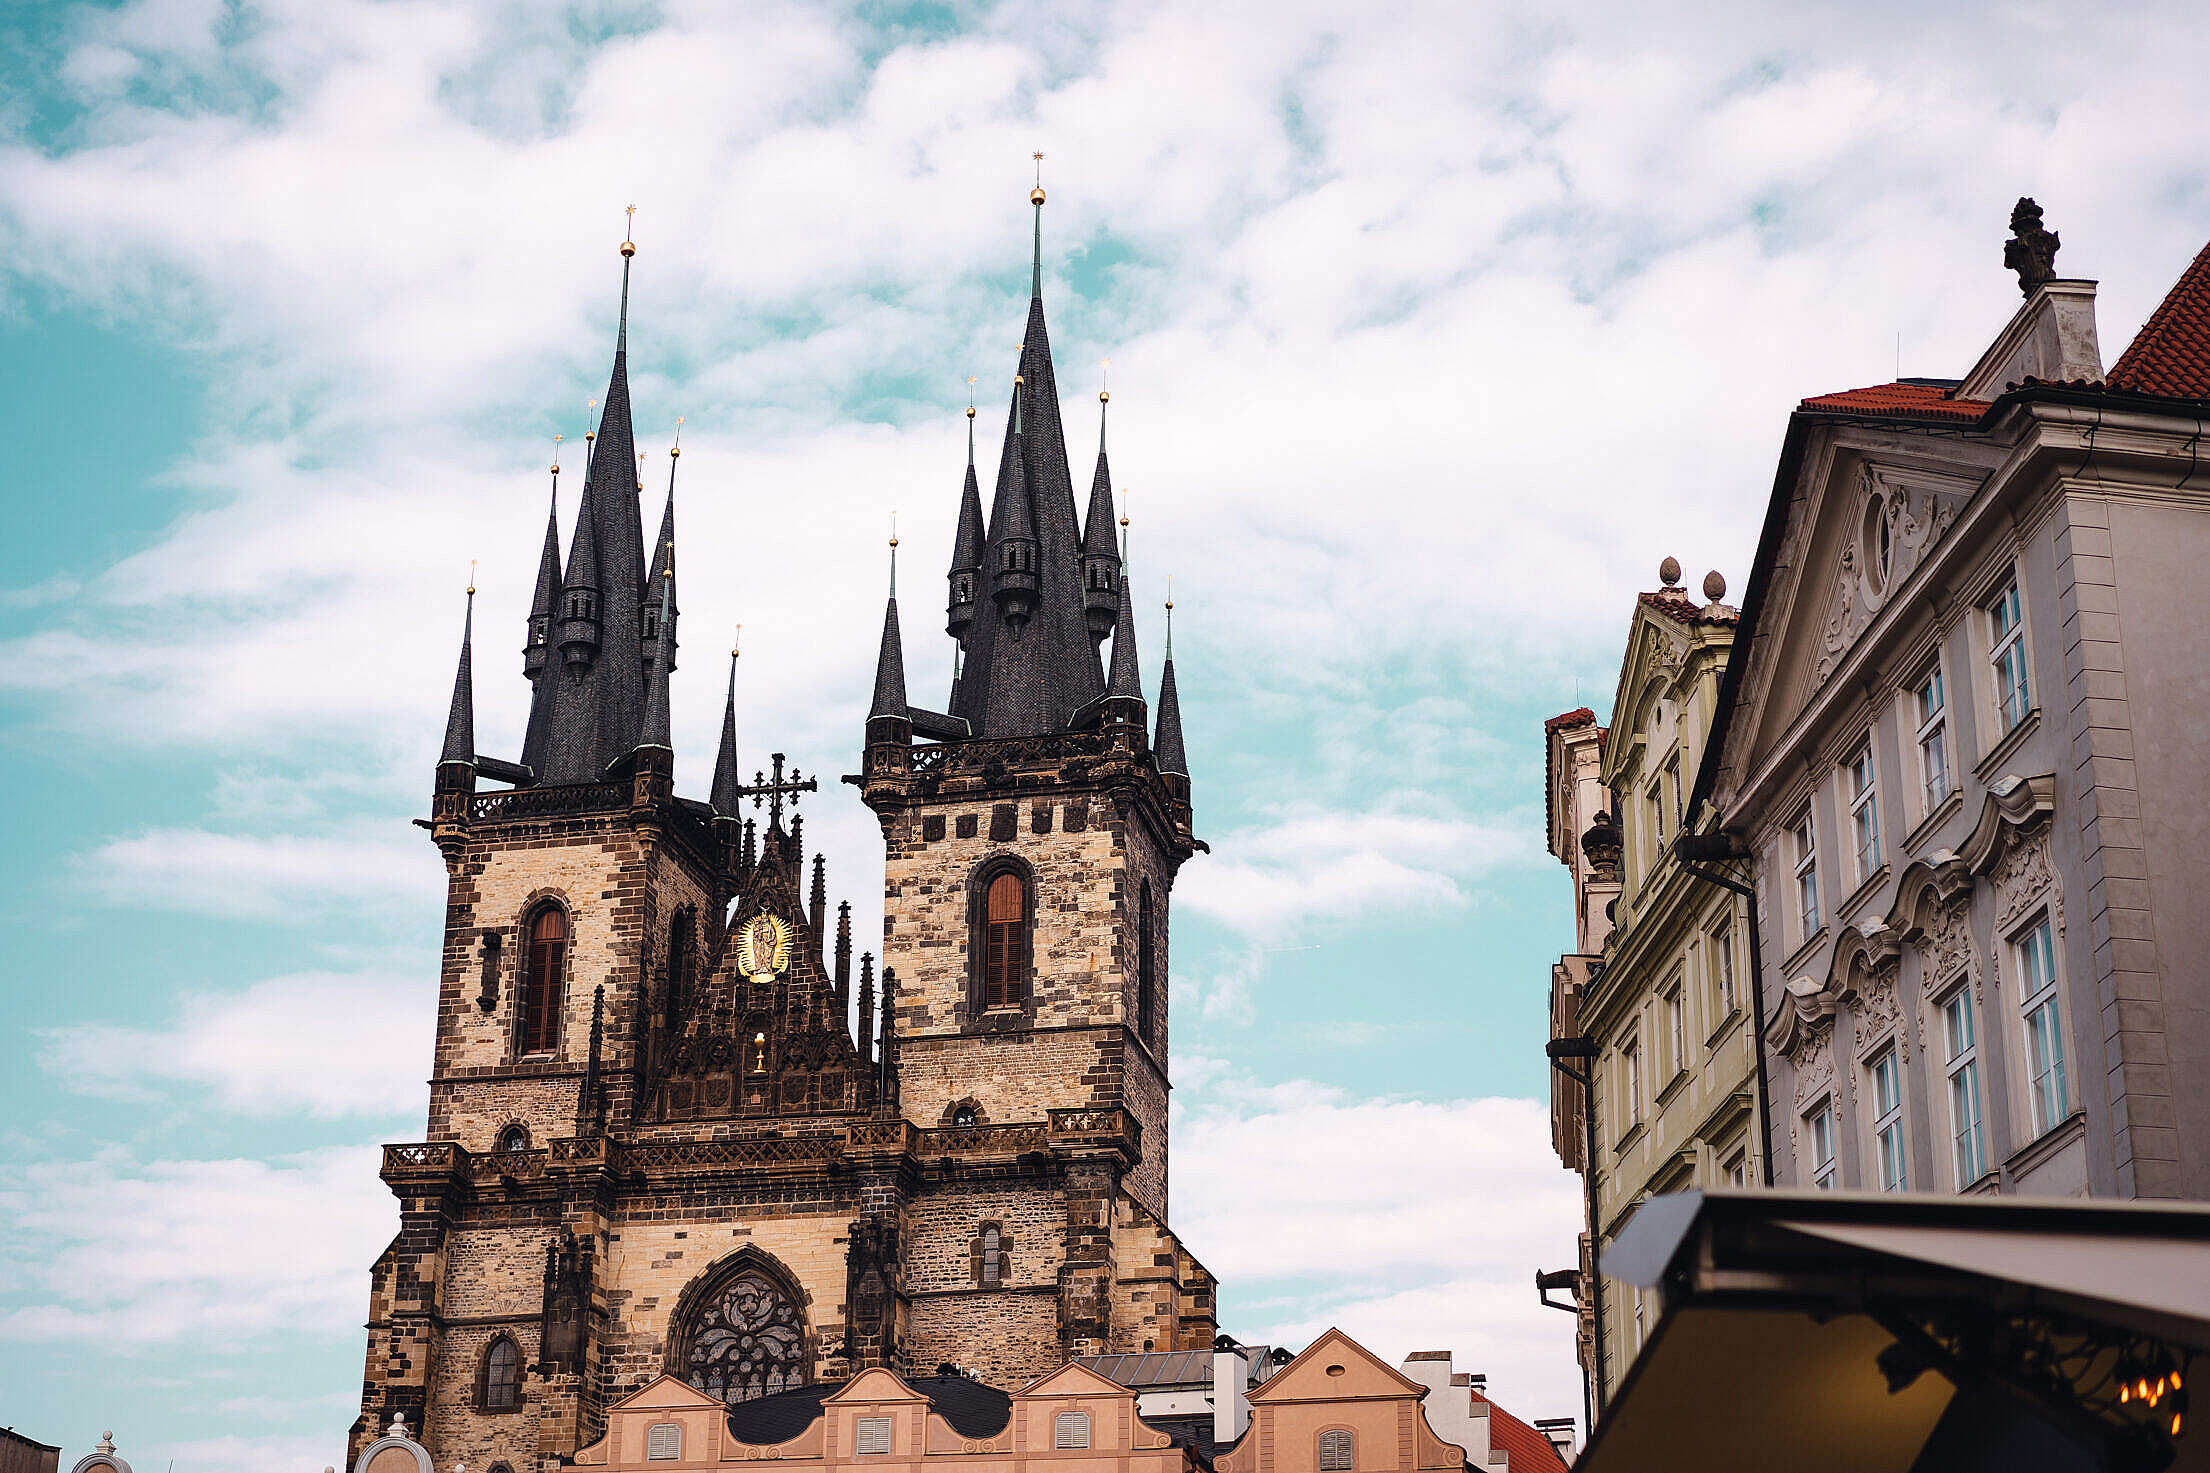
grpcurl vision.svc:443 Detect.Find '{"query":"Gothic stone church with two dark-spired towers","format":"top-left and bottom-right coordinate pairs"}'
top-left (351, 188), bottom-right (1218, 1473)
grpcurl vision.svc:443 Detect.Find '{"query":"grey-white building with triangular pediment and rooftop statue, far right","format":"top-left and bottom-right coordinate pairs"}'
top-left (1697, 213), bottom-right (2210, 1197)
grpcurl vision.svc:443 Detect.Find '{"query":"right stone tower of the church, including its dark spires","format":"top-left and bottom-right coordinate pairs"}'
top-left (857, 175), bottom-right (1213, 1376)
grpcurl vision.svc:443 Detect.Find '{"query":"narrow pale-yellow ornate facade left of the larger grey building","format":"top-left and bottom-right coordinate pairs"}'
top-left (1545, 559), bottom-right (1764, 1402)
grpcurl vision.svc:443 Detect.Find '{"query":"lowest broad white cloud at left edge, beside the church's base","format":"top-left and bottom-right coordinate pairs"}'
top-left (0, 1146), bottom-right (398, 1352)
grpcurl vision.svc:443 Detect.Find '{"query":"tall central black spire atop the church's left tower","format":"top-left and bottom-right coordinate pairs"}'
top-left (533, 226), bottom-right (652, 784)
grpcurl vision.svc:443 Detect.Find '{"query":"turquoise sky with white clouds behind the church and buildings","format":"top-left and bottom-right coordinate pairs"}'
top-left (0, 0), bottom-right (2210, 1473)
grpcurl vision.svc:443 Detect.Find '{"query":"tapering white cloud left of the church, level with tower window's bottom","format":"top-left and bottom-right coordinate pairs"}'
top-left (40, 972), bottom-right (438, 1120)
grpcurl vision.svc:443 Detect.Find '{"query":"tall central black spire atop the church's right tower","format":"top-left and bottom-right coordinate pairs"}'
top-left (950, 188), bottom-right (1105, 738)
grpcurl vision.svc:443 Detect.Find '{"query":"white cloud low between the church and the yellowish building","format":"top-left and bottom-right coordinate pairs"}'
top-left (1174, 1082), bottom-right (1582, 1416)
